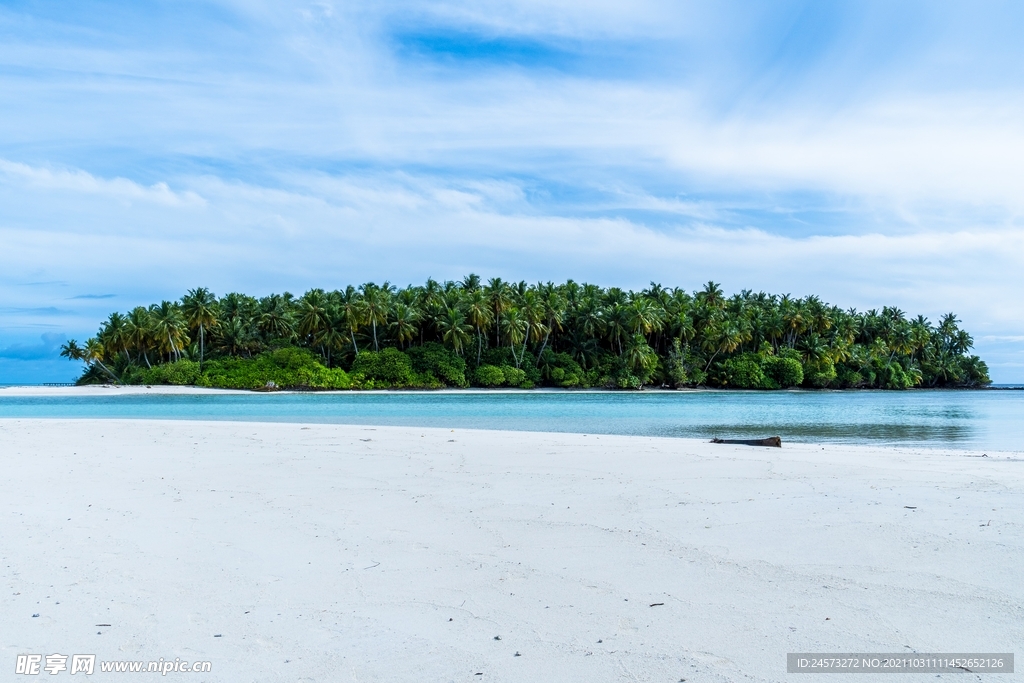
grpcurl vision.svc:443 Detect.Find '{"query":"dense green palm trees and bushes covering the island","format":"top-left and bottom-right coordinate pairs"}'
top-left (61, 275), bottom-right (989, 389)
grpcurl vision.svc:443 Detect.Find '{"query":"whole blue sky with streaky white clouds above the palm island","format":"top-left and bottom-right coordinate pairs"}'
top-left (0, 0), bottom-right (1024, 383)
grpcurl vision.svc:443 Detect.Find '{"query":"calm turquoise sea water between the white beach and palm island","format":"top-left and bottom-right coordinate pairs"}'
top-left (0, 390), bottom-right (1024, 451)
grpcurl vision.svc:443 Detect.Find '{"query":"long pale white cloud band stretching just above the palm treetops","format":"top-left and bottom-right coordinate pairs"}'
top-left (0, 162), bottom-right (1024, 315)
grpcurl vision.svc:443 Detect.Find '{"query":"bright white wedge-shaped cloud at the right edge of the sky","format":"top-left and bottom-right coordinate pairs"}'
top-left (651, 93), bottom-right (1024, 210)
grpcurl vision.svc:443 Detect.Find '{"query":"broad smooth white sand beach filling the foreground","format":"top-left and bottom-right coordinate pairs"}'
top-left (0, 420), bottom-right (1024, 683)
